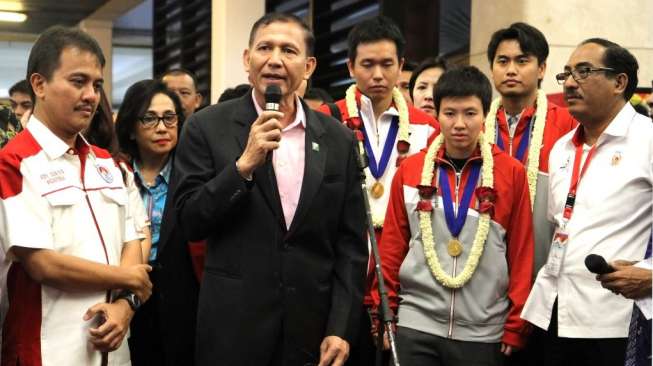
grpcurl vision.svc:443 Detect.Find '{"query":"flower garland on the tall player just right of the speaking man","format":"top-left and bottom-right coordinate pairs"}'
top-left (345, 84), bottom-right (410, 229)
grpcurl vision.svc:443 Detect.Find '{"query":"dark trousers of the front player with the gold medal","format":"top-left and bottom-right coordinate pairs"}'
top-left (397, 327), bottom-right (503, 366)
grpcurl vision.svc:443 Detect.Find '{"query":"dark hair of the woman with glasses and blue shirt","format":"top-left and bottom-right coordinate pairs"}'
top-left (116, 79), bottom-right (185, 160)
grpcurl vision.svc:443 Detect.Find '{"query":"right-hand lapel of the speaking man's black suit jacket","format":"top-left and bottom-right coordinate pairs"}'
top-left (288, 105), bottom-right (328, 236)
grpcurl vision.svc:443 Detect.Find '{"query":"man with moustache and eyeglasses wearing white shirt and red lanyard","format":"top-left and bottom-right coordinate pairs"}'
top-left (522, 38), bottom-right (653, 366)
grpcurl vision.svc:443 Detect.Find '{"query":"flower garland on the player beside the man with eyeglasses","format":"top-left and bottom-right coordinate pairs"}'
top-left (485, 90), bottom-right (549, 210)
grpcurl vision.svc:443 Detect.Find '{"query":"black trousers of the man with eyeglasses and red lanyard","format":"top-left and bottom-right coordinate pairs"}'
top-left (511, 301), bottom-right (628, 366)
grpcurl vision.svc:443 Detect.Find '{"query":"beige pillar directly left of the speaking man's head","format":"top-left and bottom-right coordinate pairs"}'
top-left (211, 0), bottom-right (265, 104)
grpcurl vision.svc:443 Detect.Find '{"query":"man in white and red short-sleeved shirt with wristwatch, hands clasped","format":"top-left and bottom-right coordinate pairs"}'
top-left (0, 27), bottom-right (152, 366)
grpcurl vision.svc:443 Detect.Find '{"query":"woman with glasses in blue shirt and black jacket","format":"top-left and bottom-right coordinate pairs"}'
top-left (116, 80), bottom-right (198, 366)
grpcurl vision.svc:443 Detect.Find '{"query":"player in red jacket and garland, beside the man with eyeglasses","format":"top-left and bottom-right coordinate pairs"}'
top-left (485, 23), bottom-right (578, 281)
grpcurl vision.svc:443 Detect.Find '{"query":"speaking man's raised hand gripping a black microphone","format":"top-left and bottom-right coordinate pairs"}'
top-left (236, 85), bottom-right (283, 179)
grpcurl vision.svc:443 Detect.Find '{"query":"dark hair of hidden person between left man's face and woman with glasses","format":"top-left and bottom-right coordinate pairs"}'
top-left (84, 88), bottom-right (118, 157)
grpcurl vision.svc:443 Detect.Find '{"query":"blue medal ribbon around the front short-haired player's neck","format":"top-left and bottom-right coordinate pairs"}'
top-left (439, 161), bottom-right (481, 238)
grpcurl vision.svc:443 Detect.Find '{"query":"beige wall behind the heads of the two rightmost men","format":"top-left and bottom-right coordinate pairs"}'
top-left (470, 0), bottom-right (653, 93)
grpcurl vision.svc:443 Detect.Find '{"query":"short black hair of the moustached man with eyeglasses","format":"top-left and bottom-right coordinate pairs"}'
top-left (581, 38), bottom-right (639, 101)
